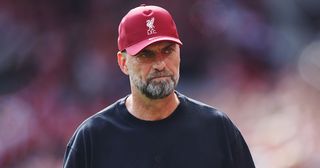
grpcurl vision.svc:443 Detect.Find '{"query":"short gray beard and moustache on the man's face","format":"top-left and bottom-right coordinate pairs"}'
top-left (130, 72), bottom-right (178, 99)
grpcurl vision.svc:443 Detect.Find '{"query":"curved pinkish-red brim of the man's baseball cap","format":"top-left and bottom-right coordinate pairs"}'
top-left (126, 36), bottom-right (182, 55)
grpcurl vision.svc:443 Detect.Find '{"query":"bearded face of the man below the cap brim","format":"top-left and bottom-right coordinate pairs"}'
top-left (126, 42), bottom-right (180, 99)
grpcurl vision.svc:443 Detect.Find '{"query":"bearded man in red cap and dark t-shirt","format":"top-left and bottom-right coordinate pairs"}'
top-left (64, 6), bottom-right (254, 168)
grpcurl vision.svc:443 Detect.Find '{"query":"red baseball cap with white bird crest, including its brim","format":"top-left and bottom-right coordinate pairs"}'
top-left (118, 5), bottom-right (182, 55)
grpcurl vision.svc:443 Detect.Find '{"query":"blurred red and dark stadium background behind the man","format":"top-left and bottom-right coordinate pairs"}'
top-left (0, 0), bottom-right (320, 168)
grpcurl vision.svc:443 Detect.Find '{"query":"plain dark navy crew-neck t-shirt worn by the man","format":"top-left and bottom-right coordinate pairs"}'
top-left (64, 92), bottom-right (255, 168)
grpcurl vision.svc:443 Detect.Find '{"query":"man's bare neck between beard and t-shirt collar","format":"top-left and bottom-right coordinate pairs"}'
top-left (126, 92), bottom-right (180, 121)
